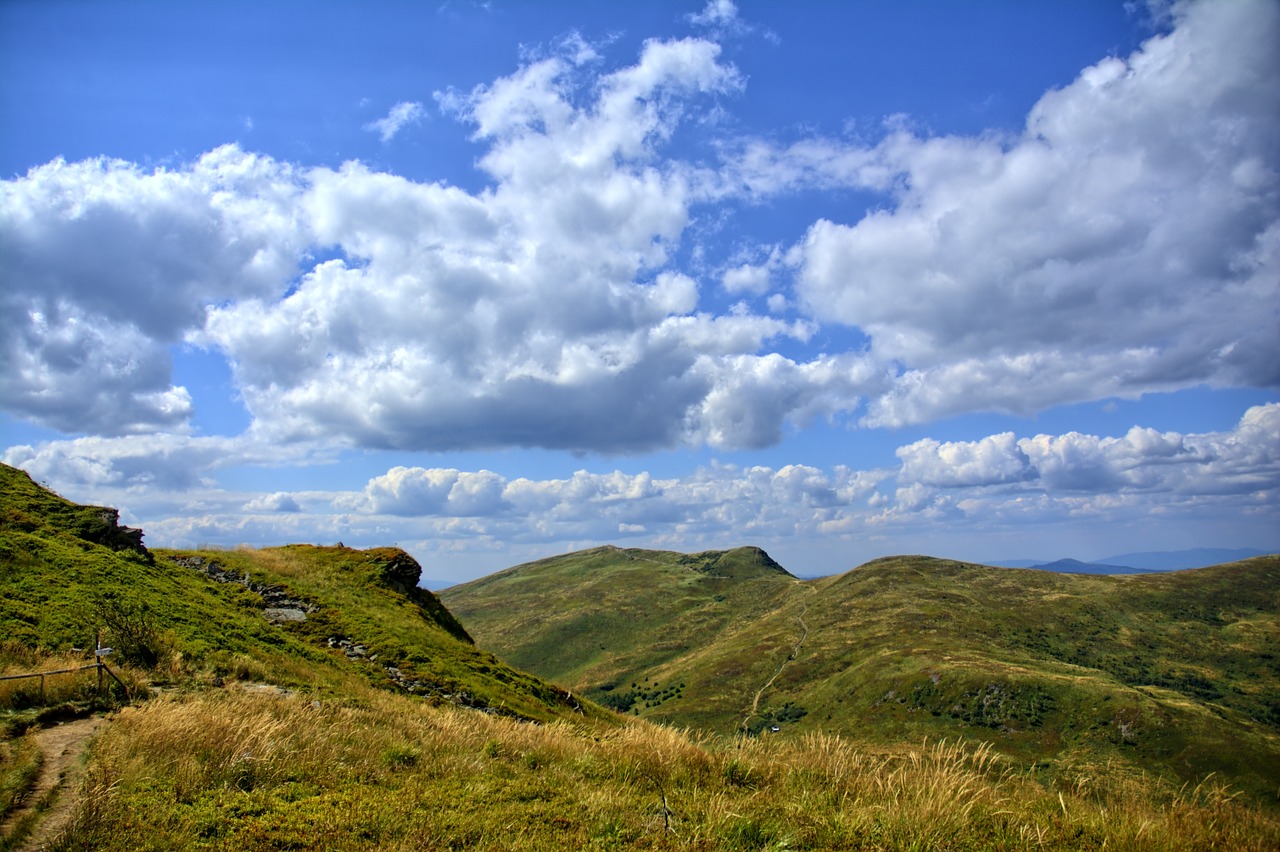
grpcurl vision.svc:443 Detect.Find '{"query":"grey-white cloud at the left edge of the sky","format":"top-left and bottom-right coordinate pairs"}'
top-left (0, 147), bottom-right (307, 435)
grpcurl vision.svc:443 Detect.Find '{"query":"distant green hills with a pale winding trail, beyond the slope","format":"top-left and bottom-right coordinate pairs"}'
top-left (442, 549), bottom-right (1280, 801)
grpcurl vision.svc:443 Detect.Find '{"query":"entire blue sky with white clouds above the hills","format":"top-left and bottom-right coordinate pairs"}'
top-left (0, 0), bottom-right (1280, 587)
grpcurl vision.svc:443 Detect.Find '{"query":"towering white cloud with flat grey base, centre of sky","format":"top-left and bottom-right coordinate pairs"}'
top-left (199, 31), bottom-right (858, 452)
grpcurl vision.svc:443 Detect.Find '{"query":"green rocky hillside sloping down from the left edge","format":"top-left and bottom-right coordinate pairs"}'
top-left (0, 466), bottom-right (579, 720)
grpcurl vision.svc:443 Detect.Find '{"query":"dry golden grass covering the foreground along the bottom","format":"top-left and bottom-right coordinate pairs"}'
top-left (55, 688), bottom-right (1280, 851)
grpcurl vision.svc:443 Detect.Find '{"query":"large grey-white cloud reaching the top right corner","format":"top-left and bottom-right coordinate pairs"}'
top-left (788, 3), bottom-right (1280, 425)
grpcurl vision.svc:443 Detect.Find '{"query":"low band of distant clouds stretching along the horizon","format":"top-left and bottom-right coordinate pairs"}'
top-left (4, 403), bottom-right (1280, 569)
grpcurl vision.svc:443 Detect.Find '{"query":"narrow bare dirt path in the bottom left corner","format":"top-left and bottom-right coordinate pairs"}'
top-left (0, 716), bottom-right (102, 852)
